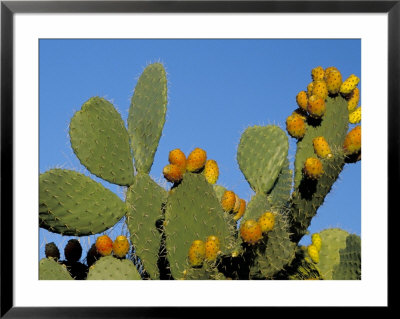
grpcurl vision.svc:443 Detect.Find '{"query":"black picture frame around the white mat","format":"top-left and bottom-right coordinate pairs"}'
top-left (0, 0), bottom-right (394, 318)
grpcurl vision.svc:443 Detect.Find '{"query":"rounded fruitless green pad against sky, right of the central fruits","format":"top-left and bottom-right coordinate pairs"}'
top-left (237, 125), bottom-right (289, 194)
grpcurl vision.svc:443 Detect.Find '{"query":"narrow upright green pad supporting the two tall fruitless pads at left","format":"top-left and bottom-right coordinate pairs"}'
top-left (126, 173), bottom-right (167, 279)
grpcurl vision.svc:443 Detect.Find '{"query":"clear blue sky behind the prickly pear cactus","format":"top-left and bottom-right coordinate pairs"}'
top-left (39, 40), bottom-right (361, 258)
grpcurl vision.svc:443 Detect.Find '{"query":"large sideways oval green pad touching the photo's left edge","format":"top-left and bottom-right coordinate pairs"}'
top-left (39, 169), bottom-right (126, 236)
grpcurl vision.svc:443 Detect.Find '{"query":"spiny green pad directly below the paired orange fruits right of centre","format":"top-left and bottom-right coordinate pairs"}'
top-left (256, 213), bottom-right (296, 279)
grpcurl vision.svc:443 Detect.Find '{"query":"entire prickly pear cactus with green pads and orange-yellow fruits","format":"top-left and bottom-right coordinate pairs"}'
top-left (39, 63), bottom-right (361, 280)
